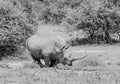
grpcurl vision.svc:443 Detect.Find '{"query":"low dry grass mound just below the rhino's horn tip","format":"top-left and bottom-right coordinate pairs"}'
top-left (73, 56), bottom-right (105, 70)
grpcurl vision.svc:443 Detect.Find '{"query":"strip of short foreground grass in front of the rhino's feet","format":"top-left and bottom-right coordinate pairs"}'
top-left (0, 68), bottom-right (120, 84)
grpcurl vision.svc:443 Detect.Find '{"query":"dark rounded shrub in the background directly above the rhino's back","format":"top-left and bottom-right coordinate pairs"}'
top-left (42, 5), bottom-right (66, 24)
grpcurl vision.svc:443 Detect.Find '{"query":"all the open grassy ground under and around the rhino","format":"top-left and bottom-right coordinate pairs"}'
top-left (0, 44), bottom-right (120, 84)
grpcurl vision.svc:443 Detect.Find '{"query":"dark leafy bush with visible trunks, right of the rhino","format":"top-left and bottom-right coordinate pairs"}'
top-left (76, 9), bottom-right (120, 43)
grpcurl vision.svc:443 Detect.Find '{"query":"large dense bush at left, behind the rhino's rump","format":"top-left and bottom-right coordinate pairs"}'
top-left (0, 1), bottom-right (33, 58)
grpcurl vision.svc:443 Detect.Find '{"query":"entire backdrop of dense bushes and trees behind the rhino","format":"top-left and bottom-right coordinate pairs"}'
top-left (0, 0), bottom-right (120, 58)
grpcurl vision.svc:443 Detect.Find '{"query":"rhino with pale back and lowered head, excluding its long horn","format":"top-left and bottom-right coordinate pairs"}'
top-left (26, 34), bottom-right (72, 67)
